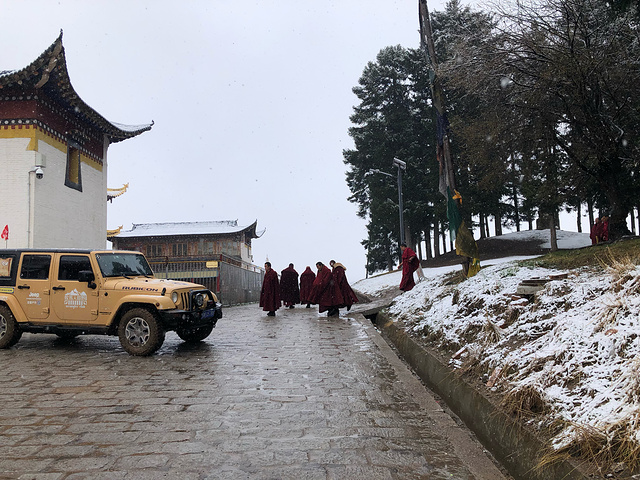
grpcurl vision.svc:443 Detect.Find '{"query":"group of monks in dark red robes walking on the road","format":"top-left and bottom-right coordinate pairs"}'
top-left (260, 260), bottom-right (358, 317)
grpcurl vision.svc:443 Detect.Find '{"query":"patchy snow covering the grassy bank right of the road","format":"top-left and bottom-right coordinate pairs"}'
top-left (354, 231), bottom-right (640, 464)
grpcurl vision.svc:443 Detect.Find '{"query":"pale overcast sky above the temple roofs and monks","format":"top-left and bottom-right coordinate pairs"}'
top-left (0, 0), bottom-right (467, 283)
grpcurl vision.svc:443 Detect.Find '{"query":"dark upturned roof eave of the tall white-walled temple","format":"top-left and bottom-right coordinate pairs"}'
top-left (0, 30), bottom-right (153, 143)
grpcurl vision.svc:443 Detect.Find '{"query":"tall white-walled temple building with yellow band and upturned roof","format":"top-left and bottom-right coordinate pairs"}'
top-left (0, 32), bottom-right (153, 249)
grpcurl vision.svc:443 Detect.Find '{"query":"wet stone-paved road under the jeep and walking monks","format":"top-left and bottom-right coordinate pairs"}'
top-left (0, 305), bottom-right (504, 480)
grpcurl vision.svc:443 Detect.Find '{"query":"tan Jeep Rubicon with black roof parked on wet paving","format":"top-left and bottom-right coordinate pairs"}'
top-left (0, 249), bottom-right (222, 355)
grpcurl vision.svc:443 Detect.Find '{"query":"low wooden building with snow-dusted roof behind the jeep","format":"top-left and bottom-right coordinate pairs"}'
top-left (109, 220), bottom-right (264, 305)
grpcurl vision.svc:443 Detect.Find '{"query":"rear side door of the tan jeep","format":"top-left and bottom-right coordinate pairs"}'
top-left (15, 253), bottom-right (51, 323)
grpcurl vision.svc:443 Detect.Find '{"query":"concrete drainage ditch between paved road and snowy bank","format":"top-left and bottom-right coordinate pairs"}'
top-left (361, 309), bottom-right (602, 480)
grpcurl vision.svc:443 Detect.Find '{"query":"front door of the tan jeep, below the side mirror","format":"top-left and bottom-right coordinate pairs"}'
top-left (51, 253), bottom-right (98, 325)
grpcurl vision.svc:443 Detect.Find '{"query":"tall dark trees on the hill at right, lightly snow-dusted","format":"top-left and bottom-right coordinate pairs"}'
top-left (343, 0), bottom-right (640, 272)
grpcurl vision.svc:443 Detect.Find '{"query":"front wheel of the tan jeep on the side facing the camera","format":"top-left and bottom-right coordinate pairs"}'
top-left (118, 308), bottom-right (164, 356)
